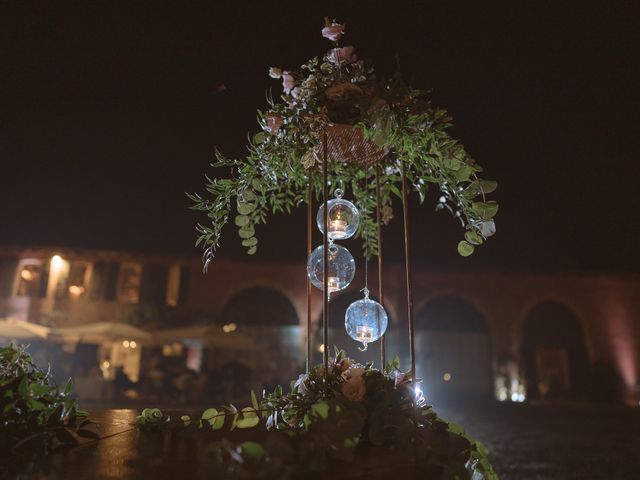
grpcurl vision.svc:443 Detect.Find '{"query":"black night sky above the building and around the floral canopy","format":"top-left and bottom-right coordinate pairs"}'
top-left (0, 1), bottom-right (640, 273)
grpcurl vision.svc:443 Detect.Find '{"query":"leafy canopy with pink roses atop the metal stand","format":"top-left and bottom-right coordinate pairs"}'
top-left (188, 19), bottom-right (498, 269)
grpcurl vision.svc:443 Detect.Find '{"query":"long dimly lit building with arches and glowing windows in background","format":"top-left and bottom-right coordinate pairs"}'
top-left (0, 247), bottom-right (640, 404)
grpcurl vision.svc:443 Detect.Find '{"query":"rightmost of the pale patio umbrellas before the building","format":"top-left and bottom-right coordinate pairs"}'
top-left (153, 325), bottom-right (260, 351)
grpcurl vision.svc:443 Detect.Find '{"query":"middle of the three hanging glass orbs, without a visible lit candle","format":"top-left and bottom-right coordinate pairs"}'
top-left (307, 244), bottom-right (356, 294)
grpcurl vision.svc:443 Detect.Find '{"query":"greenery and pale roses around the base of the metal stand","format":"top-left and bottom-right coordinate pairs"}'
top-left (138, 349), bottom-right (498, 480)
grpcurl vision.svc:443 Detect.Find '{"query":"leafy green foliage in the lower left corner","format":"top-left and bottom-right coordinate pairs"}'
top-left (0, 344), bottom-right (92, 459)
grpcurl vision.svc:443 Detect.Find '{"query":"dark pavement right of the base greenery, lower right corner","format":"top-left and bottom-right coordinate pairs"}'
top-left (436, 404), bottom-right (640, 480)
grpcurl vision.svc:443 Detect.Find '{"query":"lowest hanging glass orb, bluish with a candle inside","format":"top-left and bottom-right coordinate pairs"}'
top-left (344, 291), bottom-right (388, 352)
